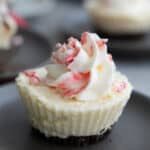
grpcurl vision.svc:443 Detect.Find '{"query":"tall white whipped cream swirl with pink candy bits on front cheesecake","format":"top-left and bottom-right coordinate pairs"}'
top-left (47, 32), bottom-right (115, 101)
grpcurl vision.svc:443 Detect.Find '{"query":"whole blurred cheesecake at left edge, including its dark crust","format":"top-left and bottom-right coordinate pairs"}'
top-left (0, 0), bottom-right (22, 65)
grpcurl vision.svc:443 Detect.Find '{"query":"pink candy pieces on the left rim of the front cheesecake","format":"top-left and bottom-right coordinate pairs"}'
top-left (24, 70), bottom-right (40, 85)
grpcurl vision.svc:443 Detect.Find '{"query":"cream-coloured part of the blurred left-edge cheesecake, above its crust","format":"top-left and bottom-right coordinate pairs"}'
top-left (0, 1), bottom-right (17, 50)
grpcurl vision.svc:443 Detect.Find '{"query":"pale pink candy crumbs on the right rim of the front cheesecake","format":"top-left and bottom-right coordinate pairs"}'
top-left (113, 81), bottom-right (127, 93)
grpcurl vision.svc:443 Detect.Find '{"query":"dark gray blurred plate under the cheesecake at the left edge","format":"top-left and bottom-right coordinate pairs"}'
top-left (0, 29), bottom-right (50, 83)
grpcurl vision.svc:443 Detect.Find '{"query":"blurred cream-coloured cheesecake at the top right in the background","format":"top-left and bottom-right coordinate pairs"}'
top-left (85, 0), bottom-right (150, 35)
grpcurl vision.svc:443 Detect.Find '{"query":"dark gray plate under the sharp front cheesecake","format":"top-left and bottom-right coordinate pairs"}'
top-left (0, 88), bottom-right (150, 150)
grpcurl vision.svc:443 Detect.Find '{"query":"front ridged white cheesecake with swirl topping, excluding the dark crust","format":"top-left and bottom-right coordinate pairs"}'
top-left (16, 32), bottom-right (132, 143)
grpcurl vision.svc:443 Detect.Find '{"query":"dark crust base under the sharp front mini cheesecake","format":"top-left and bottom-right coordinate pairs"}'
top-left (32, 128), bottom-right (112, 146)
